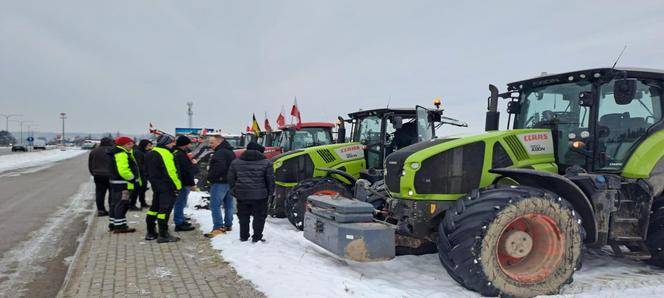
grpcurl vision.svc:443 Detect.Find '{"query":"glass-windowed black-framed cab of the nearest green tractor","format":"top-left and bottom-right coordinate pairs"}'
top-left (487, 69), bottom-right (664, 174)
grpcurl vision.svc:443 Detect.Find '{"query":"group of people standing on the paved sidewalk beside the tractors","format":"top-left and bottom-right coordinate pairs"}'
top-left (88, 134), bottom-right (274, 243)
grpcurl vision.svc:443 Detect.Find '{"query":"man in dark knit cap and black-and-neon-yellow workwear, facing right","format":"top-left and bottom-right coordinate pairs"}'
top-left (145, 134), bottom-right (182, 243)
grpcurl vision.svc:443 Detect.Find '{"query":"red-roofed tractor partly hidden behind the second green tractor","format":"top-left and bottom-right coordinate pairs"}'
top-left (234, 122), bottom-right (335, 158)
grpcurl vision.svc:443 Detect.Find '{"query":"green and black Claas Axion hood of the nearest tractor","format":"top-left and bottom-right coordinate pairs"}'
top-left (385, 129), bottom-right (557, 200)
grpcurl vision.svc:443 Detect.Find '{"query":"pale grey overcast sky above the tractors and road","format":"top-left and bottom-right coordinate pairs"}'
top-left (0, 0), bottom-right (664, 134)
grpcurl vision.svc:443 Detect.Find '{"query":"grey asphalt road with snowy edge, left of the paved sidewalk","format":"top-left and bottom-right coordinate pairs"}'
top-left (0, 154), bottom-right (95, 297)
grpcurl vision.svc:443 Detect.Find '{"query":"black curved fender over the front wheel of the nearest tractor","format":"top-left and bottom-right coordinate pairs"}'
top-left (489, 168), bottom-right (597, 243)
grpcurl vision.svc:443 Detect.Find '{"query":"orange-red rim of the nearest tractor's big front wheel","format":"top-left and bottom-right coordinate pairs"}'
top-left (496, 213), bottom-right (565, 283)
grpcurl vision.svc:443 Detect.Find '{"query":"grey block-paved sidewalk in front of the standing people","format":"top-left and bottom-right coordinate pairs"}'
top-left (62, 207), bottom-right (264, 297)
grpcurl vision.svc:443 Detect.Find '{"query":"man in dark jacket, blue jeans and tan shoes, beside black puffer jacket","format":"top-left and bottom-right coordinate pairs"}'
top-left (205, 135), bottom-right (235, 238)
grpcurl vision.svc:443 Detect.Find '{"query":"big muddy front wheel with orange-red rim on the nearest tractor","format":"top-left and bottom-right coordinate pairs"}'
top-left (437, 185), bottom-right (584, 297)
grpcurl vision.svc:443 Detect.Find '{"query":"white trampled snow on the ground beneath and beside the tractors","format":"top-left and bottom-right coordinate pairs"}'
top-left (187, 192), bottom-right (664, 298)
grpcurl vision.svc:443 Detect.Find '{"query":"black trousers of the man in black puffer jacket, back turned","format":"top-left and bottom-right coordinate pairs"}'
top-left (237, 198), bottom-right (267, 240)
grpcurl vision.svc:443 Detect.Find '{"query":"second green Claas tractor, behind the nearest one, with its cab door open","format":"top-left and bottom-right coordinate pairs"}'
top-left (270, 100), bottom-right (467, 230)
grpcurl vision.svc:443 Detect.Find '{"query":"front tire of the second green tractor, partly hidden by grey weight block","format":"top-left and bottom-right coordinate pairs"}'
top-left (284, 177), bottom-right (353, 231)
